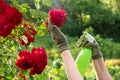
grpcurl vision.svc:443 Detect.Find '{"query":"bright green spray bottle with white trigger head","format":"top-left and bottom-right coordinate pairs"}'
top-left (75, 32), bottom-right (97, 76)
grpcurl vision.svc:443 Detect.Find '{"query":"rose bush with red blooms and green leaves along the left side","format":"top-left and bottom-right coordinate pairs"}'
top-left (0, 0), bottom-right (50, 80)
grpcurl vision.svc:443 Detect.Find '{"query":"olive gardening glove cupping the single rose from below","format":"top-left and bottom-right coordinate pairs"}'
top-left (48, 20), bottom-right (69, 52)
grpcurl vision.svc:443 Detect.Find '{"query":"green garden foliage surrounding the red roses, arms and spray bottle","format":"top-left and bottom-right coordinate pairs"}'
top-left (0, 0), bottom-right (120, 80)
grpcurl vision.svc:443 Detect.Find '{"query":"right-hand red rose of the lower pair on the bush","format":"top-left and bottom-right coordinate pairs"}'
top-left (30, 47), bottom-right (47, 75)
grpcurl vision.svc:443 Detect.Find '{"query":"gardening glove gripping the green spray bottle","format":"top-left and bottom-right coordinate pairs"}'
top-left (77, 34), bottom-right (102, 60)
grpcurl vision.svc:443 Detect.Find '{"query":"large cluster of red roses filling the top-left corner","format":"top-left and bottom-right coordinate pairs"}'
top-left (0, 0), bottom-right (22, 38)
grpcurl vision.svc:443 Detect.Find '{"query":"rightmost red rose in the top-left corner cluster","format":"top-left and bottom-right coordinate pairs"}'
top-left (5, 7), bottom-right (22, 26)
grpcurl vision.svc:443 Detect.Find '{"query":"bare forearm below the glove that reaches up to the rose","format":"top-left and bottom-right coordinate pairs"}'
top-left (61, 50), bottom-right (83, 80)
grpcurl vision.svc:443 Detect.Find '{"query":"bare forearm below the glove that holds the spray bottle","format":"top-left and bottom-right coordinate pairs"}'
top-left (93, 57), bottom-right (112, 80)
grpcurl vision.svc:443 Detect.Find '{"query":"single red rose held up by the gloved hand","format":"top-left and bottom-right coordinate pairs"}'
top-left (49, 8), bottom-right (66, 28)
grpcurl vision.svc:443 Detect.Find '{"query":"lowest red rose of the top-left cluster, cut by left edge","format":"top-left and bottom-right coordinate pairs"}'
top-left (0, 16), bottom-right (15, 37)
